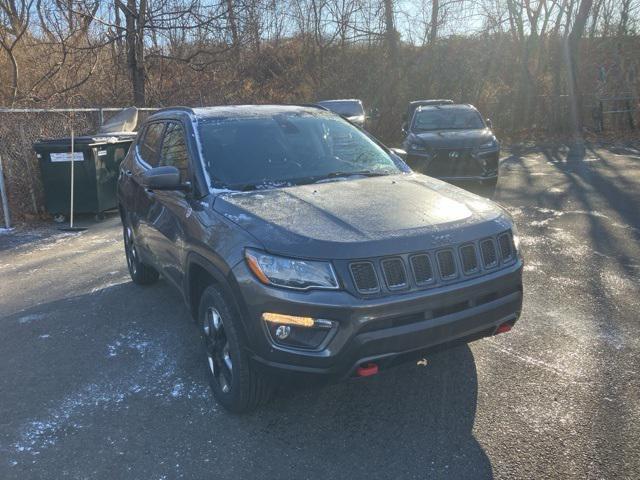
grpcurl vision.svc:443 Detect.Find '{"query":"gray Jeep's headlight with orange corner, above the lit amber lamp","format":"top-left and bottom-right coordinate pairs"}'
top-left (244, 249), bottom-right (338, 290)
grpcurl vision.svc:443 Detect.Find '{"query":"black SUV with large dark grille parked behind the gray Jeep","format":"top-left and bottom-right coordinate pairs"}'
top-left (402, 100), bottom-right (500, 189)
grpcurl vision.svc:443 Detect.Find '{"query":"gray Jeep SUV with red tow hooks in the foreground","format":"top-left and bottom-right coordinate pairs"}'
top-left (118, 105), bottom-right (522, 412)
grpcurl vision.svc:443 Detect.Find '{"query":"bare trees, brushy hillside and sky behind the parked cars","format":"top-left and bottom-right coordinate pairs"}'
top-left (0, 0), bottom-right (640, 219)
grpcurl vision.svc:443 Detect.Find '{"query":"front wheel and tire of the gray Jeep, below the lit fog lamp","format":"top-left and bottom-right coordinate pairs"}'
top-left (198, 285), bottom-right (272, 413)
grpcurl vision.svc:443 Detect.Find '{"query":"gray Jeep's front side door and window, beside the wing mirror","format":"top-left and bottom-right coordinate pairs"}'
top-left (146, 121), bottom-right (193, 286)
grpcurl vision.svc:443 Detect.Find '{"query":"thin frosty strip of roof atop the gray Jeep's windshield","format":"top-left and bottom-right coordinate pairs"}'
top-left (149, 105), bottom-right (327, 120)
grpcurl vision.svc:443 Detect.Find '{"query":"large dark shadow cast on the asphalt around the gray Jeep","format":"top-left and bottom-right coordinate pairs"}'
top-left (0, 282), bottom-right (492, 479)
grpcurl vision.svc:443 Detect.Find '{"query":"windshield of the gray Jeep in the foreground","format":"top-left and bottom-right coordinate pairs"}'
top-left (198, 111), bottom-right (403, 190)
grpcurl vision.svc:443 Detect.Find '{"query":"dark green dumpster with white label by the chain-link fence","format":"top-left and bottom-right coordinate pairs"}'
top-left (33, 133), bottom-right (136, 217)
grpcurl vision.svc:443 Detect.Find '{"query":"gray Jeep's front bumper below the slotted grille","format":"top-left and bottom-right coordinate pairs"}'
top-left (234, 260), bottom-right (522, 380)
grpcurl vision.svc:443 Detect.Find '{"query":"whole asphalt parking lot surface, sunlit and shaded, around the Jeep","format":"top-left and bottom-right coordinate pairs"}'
top-left (0, 147), bottom-right (640, 479)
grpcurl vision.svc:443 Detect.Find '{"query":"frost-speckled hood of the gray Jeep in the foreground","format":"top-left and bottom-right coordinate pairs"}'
top-left (213, 173), bottom-right (511, 260)
